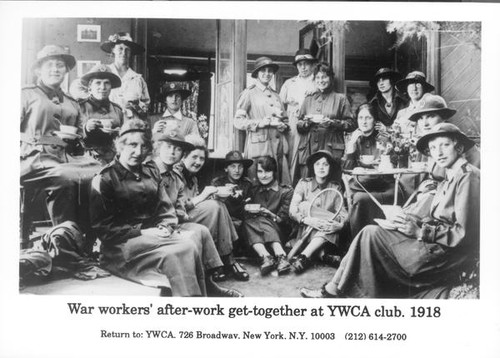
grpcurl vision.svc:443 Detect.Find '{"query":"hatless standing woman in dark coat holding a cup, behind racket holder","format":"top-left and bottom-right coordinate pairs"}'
top-left (293, 63), bottom-right (355, 180)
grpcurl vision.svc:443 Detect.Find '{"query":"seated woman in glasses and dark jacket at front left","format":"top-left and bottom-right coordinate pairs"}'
top-left (91, 119), bottom-right (241, 296)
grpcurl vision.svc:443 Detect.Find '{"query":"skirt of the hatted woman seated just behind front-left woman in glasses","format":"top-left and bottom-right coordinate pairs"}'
top-left (179, 223), bottom-right (222, 270)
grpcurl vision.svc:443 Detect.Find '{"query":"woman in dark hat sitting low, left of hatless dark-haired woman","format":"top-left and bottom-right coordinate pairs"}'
top-left (212, 150), bottom-right (253, 221)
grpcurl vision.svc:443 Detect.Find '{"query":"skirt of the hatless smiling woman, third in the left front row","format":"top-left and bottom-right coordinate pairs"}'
top-left (188, 200), bottom-right (238, 256)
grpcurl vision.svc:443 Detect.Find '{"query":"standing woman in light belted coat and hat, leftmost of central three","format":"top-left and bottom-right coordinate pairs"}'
top-left (234, 57), bottom-right (291, 184)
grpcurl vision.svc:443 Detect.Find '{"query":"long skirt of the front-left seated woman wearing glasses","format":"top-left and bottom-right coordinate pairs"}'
top-left (101, 231), bottom-right (206, 296)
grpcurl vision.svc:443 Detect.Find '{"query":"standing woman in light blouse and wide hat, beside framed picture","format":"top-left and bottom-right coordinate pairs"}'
top-left (70, 32), bottom-right (151, 120)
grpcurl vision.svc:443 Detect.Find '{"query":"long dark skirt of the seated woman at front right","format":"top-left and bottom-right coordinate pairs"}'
top-left (331, 225), bottom-right (467, 298)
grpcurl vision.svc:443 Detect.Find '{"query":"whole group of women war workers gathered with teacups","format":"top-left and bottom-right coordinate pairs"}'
top-left (21, 33), bottom-right (479, 297)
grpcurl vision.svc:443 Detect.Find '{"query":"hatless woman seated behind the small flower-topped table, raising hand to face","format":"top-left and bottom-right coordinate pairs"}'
top-left (343, 103), bottom-right (394, 237)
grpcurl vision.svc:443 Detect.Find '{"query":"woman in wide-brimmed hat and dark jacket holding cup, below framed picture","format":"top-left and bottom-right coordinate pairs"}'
top-left (78, 65), bottom-right (123, 164)
